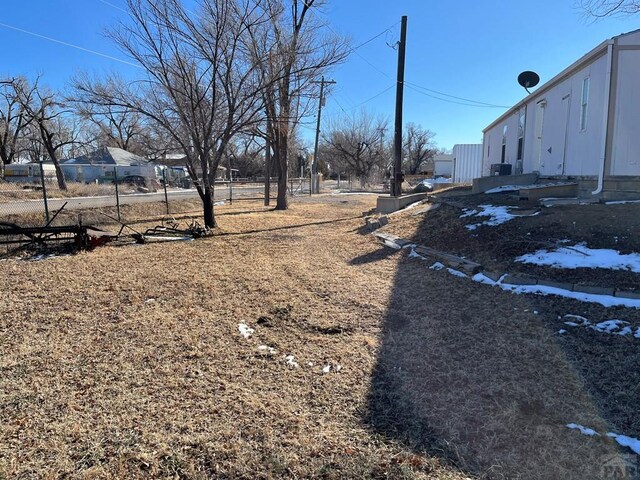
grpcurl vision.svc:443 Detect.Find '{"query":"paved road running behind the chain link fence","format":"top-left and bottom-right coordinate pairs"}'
top-left (0, 185), bottom-right (264, 216)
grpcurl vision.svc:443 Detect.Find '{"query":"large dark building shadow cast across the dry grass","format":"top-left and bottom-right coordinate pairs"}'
top-left (364, 219), bottom-right (619, 479)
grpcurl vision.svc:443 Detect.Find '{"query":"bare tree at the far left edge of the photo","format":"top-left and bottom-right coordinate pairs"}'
top-left (0, 78), bottom-right (33, 176)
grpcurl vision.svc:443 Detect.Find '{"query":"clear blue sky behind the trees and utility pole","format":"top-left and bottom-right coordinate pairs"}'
top-left (0, 0), bottom-right (640, 148)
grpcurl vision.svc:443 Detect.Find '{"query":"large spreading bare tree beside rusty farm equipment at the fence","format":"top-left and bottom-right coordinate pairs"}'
top-left (74, 0), bottom-right (265, 228)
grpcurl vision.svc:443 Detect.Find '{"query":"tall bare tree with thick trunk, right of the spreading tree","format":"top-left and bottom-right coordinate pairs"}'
top-left (251, 0), bottom-right (349, 210)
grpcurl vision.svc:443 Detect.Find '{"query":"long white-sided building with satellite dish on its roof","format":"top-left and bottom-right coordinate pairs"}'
top-left (482, 30), bottom-right (640, 199)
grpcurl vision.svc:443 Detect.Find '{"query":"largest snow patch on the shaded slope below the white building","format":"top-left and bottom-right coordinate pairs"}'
top-left (516, 243), bottom-right (640, 273)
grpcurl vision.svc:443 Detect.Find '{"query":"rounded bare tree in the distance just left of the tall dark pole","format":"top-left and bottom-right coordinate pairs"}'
top-left (323, 111), bottom-right (387, 187)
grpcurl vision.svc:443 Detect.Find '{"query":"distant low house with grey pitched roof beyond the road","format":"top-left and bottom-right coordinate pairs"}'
top-left (60, 147), bottom-right (159, 183)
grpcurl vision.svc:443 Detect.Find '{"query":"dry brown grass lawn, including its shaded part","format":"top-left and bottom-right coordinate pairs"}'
top-left (0, 193), bottom-right (632, 479)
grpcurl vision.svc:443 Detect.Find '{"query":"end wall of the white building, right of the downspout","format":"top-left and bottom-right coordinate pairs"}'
top-left (610, 50), bottom-right (640, 176)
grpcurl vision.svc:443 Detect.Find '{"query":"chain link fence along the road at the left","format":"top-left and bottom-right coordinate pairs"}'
top-left (0, 169), bottom-right (322, 226)
